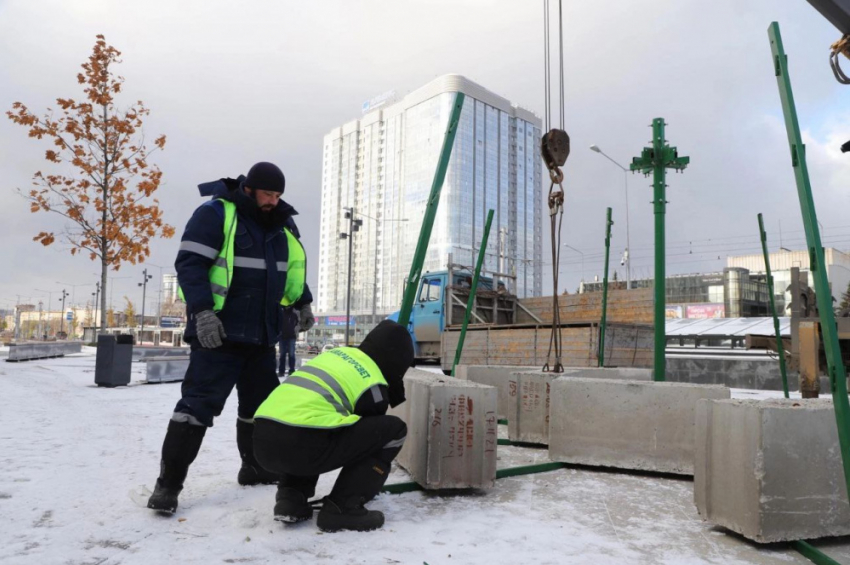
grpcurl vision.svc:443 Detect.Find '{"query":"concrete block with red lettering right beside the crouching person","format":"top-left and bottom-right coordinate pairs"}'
top-left (390, 369), bottom-right (498, 489)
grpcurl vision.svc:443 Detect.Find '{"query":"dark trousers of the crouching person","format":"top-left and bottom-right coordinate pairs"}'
top-left (254, 416), bottom-right (407, 503)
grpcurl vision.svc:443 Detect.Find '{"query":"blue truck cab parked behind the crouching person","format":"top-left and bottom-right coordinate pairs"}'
top-left (387, 270), bottom-right (493, 361)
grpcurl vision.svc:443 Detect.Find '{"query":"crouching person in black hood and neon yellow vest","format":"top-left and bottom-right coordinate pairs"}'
top-left (254, 320), bottom-right (413, 532)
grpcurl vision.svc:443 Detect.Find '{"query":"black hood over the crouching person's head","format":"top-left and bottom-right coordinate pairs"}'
top-left (359, 320), bottom-right (413, 406)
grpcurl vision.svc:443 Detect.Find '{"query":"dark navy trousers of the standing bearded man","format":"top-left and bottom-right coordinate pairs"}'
top-left (174, 341), bottom-right (280, 426)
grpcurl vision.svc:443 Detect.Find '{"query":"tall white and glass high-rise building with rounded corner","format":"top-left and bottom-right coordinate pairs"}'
top-left (317, 75), bottom-right (543, 332)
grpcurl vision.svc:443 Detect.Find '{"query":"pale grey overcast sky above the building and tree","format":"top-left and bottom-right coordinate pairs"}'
top-left (0, 0), bottom-right (850, 309)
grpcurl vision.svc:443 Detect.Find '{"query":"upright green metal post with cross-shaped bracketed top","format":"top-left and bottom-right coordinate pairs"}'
top-left (630, 118), bottom-right (690, 381)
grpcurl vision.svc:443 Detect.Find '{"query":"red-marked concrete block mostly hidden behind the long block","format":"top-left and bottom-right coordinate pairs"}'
top-left (506, 367), bottom-right (652, 445)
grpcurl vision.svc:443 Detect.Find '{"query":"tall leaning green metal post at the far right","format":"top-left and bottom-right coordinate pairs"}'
top-left (767, 22), bottom-right (850, 502)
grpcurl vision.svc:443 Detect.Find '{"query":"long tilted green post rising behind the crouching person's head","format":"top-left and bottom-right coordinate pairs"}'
top-left (398, 92), bottom-right (464, 327)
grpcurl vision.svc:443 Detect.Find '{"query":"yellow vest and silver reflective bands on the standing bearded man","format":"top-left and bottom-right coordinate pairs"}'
top-left (177, 198), bottom-right (307, 312)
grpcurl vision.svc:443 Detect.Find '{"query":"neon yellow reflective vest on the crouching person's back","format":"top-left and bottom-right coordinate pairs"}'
top-left (254, 347), bottom-right (387, 429)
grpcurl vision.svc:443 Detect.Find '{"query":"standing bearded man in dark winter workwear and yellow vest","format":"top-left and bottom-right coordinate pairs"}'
top-left (148, 163), bottom-right (315, 513)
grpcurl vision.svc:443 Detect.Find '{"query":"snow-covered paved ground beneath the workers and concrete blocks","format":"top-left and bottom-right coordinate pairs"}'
top-left (0, 348), bottom-right (850, 565)
